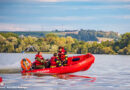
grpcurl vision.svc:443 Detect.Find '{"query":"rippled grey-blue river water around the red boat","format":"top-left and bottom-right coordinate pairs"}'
top-left (0, 53), bottom-right (130, 90)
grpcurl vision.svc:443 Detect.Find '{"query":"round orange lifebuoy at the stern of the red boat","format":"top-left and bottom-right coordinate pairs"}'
top-left (21, 58), bottom-right (32, 71)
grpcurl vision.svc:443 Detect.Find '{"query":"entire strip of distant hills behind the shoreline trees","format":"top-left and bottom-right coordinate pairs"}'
top-left (0, 30), bottom-right (119, 41)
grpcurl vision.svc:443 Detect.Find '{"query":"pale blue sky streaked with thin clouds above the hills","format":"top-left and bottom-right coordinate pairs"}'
top-left (0, 0), bottom-right (130, 34)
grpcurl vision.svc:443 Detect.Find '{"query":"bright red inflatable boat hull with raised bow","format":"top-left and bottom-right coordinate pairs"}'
top-left (21, 54), bottom-right (95, 74)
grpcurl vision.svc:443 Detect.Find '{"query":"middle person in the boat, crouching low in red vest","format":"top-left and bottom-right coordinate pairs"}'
top-left (50, 53), bottom-right (61, 68)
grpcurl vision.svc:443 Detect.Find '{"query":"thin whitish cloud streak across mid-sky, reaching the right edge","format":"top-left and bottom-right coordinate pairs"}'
top-left (39, 15), bottom-right (130, 22)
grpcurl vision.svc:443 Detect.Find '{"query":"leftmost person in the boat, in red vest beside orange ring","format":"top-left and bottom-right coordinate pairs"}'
top-left (35, 52), bottom-right (46, 69)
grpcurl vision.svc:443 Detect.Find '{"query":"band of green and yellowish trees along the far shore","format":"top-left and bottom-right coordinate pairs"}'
top-left (0, 33), bottom-right (130, 55)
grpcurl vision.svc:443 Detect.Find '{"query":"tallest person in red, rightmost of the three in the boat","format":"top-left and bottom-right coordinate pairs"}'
top-left (58, 47), bottom-right (68, 66)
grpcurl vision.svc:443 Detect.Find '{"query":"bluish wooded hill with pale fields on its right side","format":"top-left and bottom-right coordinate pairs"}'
top-left (66, 30), bottom-right (119, 41)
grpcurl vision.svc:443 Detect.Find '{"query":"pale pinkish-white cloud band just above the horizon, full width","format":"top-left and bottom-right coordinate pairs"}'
top-left (0, 23), bottom-right (130, 33)
